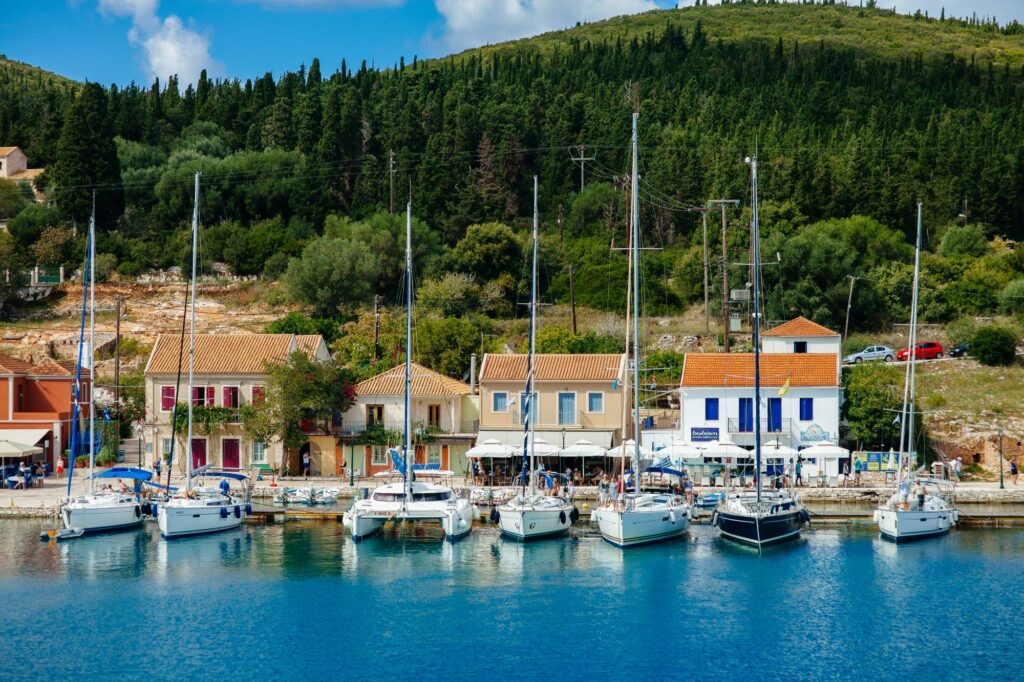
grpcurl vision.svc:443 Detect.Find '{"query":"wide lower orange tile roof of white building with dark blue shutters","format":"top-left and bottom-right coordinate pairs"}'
top-left (681, 353), bottom-right (839, 388)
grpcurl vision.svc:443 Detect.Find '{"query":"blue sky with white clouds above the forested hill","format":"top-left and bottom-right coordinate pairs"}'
top-left (0, 0), bottom-right (1024, 84)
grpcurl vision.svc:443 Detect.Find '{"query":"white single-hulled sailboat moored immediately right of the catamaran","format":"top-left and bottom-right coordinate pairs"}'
top-left (498, 175), bottom-right (579, 540)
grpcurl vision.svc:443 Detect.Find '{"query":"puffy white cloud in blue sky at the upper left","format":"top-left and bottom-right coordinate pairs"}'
top-left (99, 0), bottom-right (221, 83)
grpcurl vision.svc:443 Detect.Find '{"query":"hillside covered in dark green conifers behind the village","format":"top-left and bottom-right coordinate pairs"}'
top-left (0, 4), bottom-right (1024, 326)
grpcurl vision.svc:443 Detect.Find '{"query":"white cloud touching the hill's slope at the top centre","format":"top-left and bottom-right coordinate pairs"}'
top-left (434, 0), bottom-right (657, 50)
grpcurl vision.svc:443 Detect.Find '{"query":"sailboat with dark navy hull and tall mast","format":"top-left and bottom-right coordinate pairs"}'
top-left (712, 156), bottom-right (810, 549)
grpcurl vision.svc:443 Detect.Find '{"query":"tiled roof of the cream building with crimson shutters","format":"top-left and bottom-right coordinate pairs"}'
top-left (145, 334), bottom-right (309, 374)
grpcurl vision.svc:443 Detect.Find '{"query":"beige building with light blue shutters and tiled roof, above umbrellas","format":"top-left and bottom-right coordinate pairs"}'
top-left (477, 353), bottom-right (626, 447)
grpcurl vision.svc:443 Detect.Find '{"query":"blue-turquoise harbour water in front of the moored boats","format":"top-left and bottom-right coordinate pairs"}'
top-left (0, 521), bottom-right (1024, 682)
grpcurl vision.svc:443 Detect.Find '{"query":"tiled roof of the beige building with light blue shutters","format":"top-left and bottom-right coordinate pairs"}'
top-left (480, 353), bottom-right (624, 382)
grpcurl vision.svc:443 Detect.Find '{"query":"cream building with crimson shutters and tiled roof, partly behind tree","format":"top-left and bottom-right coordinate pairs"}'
top-left (145, 334), bottom-right (327, 475)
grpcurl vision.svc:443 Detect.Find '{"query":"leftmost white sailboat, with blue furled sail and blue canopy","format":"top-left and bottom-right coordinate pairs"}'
top-left (60, 200), bottom-right (153, 532)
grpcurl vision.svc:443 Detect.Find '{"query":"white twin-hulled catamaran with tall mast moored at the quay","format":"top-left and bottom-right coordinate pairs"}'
top-left (342, 202), bottom-right (473, 541)
